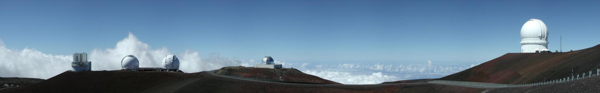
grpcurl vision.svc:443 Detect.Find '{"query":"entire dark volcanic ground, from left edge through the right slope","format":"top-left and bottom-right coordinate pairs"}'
top-left (0, 45), bottom-right (600, 93)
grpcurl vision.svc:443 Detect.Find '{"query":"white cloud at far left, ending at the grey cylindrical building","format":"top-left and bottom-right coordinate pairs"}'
top-left (0, 40), bottom-right (73, 78)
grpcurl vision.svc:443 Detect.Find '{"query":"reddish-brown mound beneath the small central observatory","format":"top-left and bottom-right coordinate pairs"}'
top-left (216, 66), bottom-right (340, 84)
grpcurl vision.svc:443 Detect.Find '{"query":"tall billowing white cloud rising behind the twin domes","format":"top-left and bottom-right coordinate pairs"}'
top-left (89, 33), bottom-right (240, 72)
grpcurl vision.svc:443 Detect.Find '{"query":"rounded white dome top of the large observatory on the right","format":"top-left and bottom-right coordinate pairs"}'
top-left (521, 19), bottom-right (548, 40)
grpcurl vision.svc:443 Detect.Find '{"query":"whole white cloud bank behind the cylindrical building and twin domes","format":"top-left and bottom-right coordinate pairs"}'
top-left (0, 33), bottom-right (241, 79)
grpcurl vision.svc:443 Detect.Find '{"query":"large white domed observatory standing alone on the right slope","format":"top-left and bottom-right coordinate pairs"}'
top-left (521, 19), bottom-right (548, 53)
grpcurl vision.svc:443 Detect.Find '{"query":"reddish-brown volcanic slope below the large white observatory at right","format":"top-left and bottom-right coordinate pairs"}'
top-left (440, 45), bottom-right (600, 84)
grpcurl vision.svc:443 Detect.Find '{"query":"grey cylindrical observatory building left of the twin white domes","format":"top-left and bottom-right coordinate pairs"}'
top-left (71, 53), bottom-right (92, 72)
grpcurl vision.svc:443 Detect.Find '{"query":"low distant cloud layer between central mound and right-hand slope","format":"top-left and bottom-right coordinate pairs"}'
top-left (283, 61), bottom-right (479, 84)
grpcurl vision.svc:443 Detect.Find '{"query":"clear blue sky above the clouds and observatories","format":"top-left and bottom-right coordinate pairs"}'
top-left (0, 0), bottom-right (600, 62)
